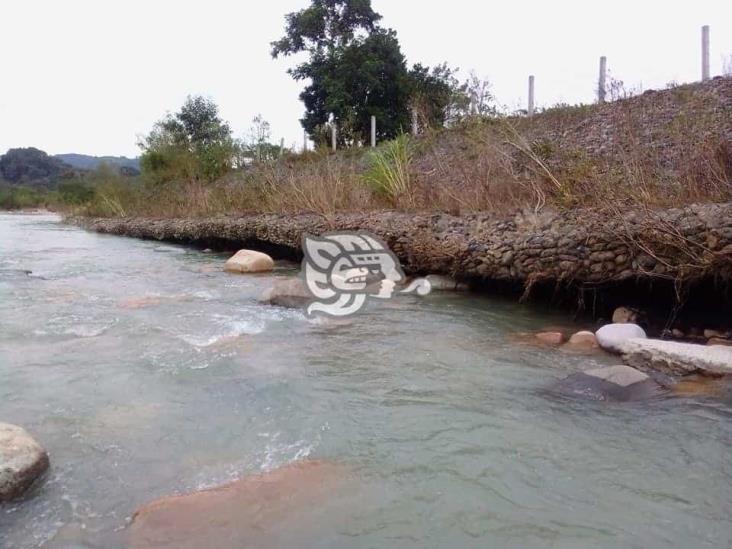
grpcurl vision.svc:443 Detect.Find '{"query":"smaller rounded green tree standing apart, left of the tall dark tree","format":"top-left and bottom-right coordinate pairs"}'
top-left (140, 96), bottom-right (237, 183)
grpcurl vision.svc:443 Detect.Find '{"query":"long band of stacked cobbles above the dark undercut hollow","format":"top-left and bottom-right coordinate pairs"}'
top-left (71, 203), bottom-right (732, 284)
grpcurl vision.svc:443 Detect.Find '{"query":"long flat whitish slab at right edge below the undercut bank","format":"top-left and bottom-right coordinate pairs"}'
top-left (623, 339), bottom-right (732, 376)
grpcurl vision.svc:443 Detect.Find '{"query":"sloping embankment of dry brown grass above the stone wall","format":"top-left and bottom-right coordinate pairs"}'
top-left (80, 76), bottom-right (732, 218)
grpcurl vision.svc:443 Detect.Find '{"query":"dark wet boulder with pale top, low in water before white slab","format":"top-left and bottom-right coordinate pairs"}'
top-left (555, 365), bottom-right (662, 401)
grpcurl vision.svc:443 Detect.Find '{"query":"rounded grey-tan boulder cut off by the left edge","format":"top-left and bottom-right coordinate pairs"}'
top-left (0, 423), bottom-right (48, 502)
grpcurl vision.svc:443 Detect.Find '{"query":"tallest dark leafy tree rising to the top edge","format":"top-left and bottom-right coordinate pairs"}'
top-left (272, 0), bottom-right (409, 144)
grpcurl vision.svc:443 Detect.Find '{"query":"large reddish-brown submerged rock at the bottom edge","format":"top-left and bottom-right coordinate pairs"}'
top-left (130, 460), bottom-right (345, 549)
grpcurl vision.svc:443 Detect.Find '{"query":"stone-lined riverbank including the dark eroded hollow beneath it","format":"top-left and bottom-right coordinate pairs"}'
top-left (67, 203), bottom-right (732, 329)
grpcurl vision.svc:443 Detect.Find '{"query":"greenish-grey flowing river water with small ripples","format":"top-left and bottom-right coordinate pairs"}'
top-left (0, 214), bottom-right (732, 548)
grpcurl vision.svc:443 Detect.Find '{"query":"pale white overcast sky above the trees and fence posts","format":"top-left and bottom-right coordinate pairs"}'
top-left (0, 0), bottom-right (732, 156)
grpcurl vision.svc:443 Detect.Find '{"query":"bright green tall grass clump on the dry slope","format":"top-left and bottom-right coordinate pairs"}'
top-left (364, 134), bottom-right (413, 206)
